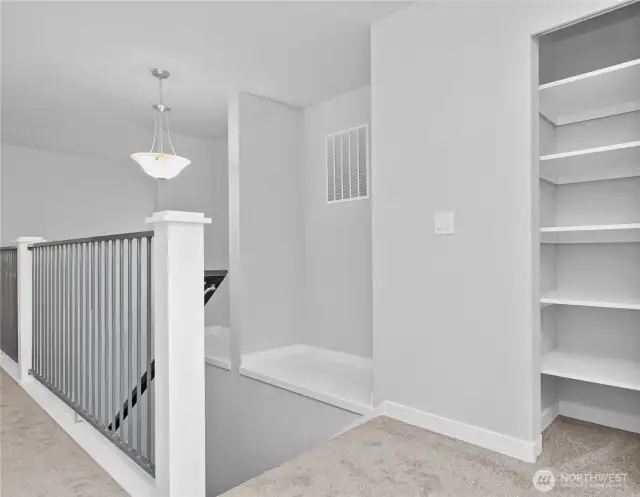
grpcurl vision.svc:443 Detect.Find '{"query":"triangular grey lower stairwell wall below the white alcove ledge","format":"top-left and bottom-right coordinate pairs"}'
top-left (206, 366), bottom-right (360, 496)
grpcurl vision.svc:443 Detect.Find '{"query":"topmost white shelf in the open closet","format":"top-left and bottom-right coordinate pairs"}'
top-left (540, 59), bottom-right (640, 126)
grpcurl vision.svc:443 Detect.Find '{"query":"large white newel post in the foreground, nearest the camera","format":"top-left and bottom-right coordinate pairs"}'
top-left (147, 211), bottom-right (211, 497)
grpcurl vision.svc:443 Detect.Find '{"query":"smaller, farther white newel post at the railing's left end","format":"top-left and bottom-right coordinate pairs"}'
top-left (16, 236), bottom-right (44, 382)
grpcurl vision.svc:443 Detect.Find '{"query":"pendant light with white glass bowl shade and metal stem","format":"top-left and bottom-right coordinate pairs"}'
top-left (131, 69), bottom-right (191, 179)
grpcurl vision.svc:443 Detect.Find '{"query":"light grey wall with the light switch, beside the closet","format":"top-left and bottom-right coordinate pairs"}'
top-left (372, 0), bottom-right (615, 442)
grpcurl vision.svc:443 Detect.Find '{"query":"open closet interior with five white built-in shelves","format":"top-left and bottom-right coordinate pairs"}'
top-left (539, 0), bottom-right (640, 432)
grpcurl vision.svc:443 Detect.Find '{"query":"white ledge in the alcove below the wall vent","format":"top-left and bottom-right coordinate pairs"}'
top-left (240, 345), bottom-right (373, 414)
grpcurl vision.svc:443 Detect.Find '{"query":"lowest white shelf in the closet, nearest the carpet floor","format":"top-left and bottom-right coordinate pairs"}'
top-left (542, 350), bottom-right (640, 390)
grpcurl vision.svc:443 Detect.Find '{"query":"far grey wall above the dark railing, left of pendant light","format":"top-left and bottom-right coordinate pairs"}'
top-left (1, 144), bottom-right (156, 244)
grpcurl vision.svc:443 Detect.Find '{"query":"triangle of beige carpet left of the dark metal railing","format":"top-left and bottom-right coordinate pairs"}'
top-left (0, 370), bottom-right (128, 497)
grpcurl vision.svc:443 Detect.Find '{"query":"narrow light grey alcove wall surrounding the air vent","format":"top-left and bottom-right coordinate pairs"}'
top-left (302, 87), bottom-right (373, 357)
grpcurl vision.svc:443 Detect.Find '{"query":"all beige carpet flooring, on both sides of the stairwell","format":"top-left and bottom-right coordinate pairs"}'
top-left (0, 364), bottom-right (640, 497)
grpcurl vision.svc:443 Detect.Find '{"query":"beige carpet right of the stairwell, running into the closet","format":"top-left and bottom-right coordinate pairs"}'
top-left (223, 417), bottom-right (640, 497)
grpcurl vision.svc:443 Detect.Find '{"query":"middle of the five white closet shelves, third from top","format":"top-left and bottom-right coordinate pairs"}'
top-left (540, 223), bottom-right (640, 243)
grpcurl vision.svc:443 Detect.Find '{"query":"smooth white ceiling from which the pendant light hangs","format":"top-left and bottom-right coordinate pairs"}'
top-left (2, 1), bottom-right (404, 151)
